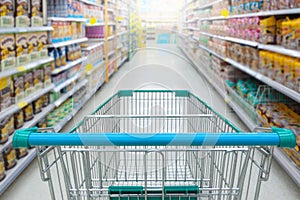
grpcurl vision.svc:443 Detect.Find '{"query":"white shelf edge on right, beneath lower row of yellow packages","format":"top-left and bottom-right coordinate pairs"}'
top-left (199, 45), bottom-right (300, 103)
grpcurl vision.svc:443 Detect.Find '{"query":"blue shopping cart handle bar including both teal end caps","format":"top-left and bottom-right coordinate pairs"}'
top-left (13, 128), bottom-right (296, 148)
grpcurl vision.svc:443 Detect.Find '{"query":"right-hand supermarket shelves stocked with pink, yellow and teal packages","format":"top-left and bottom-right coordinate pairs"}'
top-left (179, 0), bottom-right (300, 185)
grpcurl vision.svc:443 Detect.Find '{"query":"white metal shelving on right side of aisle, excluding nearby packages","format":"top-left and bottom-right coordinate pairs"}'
top-left (179, 0), bottom-right (300, 186)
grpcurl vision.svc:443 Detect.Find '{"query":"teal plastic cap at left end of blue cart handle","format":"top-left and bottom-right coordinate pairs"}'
top-left (12, 127), bottom-right (38, 148)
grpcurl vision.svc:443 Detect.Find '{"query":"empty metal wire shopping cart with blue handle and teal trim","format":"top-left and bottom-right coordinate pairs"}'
top-left (13, 91), bottom-right (296, 200)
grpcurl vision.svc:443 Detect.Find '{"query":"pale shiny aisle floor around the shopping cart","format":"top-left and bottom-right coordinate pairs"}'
top-left (0, 45), bottom-right (300, 200)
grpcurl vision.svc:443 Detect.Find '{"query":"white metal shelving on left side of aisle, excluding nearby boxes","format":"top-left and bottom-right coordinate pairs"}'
top-left (0, 0), bottom-right (133, 194)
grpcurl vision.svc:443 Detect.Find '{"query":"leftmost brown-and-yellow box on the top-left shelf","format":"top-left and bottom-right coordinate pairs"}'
top-left (0, 0), bottom-right (15, 28)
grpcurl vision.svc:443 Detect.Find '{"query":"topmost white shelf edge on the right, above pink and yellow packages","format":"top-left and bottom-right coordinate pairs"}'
top-left (200, 8), bottom-right (300, 21)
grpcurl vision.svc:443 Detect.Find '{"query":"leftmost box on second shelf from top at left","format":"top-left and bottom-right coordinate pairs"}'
top-left (0, 34), bottom-right (16, 71)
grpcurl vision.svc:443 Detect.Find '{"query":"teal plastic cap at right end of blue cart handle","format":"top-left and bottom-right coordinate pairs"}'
top-left (272, 127), bottom-right (296, 148)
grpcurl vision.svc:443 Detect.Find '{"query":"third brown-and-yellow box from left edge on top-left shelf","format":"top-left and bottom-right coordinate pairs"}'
top-left (30, 0), bottom-right (43, 26)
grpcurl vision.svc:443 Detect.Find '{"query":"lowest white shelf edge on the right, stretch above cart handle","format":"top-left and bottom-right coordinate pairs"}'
top-left (181, 48), bottom-right (257, 130)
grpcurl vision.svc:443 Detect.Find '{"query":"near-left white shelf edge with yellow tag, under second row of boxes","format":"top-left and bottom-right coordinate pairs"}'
top-left (0, 57), bottom-right (54, 78)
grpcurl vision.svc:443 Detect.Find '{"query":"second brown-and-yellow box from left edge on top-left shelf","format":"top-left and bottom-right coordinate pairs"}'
top-left (15, 0), bottom-right (29, 27)
